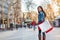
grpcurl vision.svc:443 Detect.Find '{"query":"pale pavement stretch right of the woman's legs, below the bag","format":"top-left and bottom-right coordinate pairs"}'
top-left (46, 27), bottom-right (60, 40)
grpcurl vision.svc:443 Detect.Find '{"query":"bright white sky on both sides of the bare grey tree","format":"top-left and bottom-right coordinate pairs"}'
top-left (21, 0), bottom-right (50, 12)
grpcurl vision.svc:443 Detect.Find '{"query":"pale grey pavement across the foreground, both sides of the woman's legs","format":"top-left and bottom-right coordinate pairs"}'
top-left (0, 28), bottom-right (60, 40)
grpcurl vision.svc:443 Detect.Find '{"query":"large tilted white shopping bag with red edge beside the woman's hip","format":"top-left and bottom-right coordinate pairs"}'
top-left (38, 20), bottom-right (53, 33)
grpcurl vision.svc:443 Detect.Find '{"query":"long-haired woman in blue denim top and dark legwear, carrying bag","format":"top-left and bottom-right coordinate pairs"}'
top-left (37, 6), bottom-right (46, 40)
